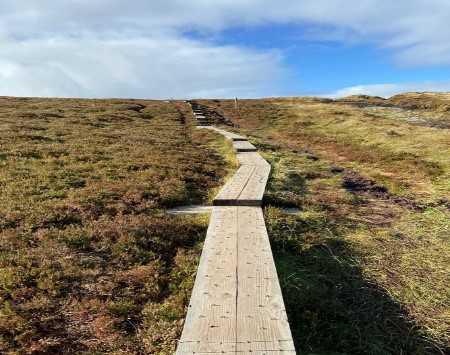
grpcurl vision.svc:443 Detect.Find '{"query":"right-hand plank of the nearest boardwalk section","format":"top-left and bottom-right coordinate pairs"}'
top-left (237, 207), bottom-right (295, 351)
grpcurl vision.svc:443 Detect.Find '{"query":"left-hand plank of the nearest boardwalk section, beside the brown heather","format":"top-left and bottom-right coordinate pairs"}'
top-left (177, 207), bottom-right (237, 354)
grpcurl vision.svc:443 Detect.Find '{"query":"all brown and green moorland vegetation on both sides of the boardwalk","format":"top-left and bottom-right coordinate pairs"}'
top-left (0, 94), bottom-right (450, 354)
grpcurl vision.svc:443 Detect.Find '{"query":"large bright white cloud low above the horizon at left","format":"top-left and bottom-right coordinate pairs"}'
top-left (0, 36), bottom-right (283, 98)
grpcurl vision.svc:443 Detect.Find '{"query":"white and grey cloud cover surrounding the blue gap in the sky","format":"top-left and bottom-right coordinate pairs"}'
top-left (0, 0), bottom-right (450, 98)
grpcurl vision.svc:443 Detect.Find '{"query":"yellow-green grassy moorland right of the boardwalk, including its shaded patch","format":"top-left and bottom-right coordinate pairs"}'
top-left (200, 94), bottom-right (450, 354)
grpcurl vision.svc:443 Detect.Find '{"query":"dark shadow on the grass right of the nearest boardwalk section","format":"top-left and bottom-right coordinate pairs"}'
top-left (273, 234), bottom-right (443, 355)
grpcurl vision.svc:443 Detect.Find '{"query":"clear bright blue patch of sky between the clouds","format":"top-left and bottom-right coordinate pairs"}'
top-left (198, 24), bottom-right (450, 95)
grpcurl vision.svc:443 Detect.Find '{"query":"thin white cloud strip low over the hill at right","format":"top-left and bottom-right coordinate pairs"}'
top-left (322, 81), bottom-right (450, 98)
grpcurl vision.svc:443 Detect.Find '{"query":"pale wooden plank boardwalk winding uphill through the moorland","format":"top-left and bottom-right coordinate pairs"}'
top-left (176, 110), bottom-right (295, 355)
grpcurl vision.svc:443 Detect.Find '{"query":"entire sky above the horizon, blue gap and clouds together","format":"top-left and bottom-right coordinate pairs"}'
top-left (0, 0), bottom-right (450, 98)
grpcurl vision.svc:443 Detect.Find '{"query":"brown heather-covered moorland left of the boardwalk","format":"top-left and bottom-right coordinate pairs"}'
top-left (0, 98), bottom-right (232, 354)
